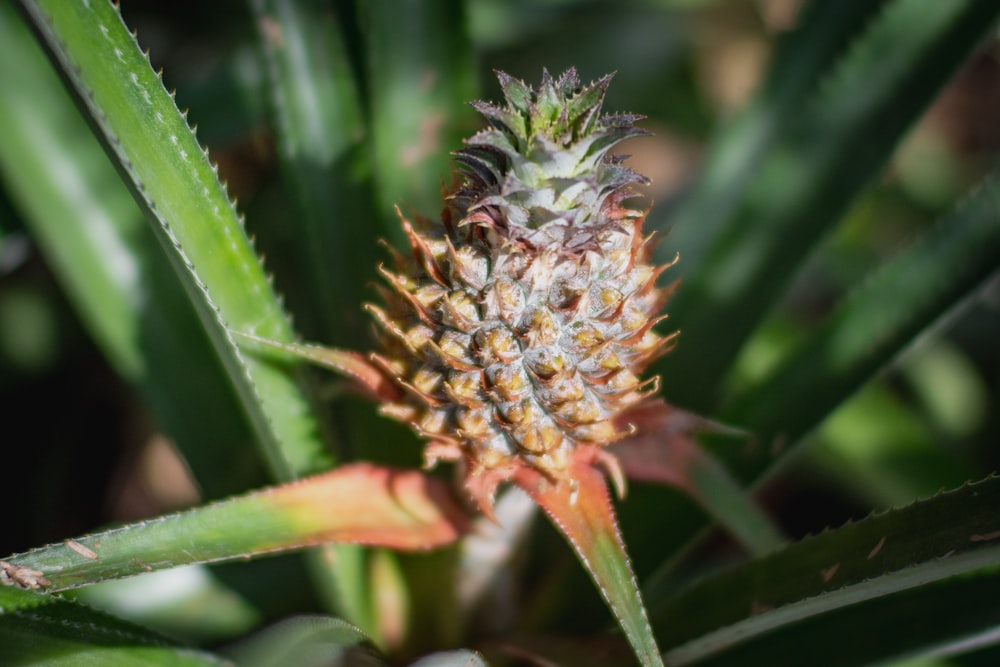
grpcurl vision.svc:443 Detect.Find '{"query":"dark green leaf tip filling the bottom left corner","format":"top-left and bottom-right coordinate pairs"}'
top-left (0, 586), bottom-right (231, 667)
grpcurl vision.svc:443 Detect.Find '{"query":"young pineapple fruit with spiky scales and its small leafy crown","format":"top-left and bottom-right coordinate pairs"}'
top-left (369, 69), bottom-right (669, 513)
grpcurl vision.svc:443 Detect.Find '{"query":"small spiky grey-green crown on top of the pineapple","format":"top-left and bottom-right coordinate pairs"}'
top-left (449, 68), bottom-right (648, 246)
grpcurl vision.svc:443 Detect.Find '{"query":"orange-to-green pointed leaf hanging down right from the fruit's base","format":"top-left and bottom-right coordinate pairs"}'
top-left (513, 461), bottom-right (663, 667)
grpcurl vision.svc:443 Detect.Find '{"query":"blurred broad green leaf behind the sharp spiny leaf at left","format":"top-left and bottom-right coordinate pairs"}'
top-left (0, 4), bottom-right (263, 498)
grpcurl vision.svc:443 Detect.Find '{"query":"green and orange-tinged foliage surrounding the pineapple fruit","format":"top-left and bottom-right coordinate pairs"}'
top-left (0, 0), bottom-right (1000, 665)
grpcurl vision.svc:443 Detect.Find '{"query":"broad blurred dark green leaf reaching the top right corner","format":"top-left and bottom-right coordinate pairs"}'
top-left (662, 0), bottom-right (1000, 410)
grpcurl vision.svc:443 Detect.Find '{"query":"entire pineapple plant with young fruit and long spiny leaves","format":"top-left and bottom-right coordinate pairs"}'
top-left (0, 0), bottom-right (1000, 667)
